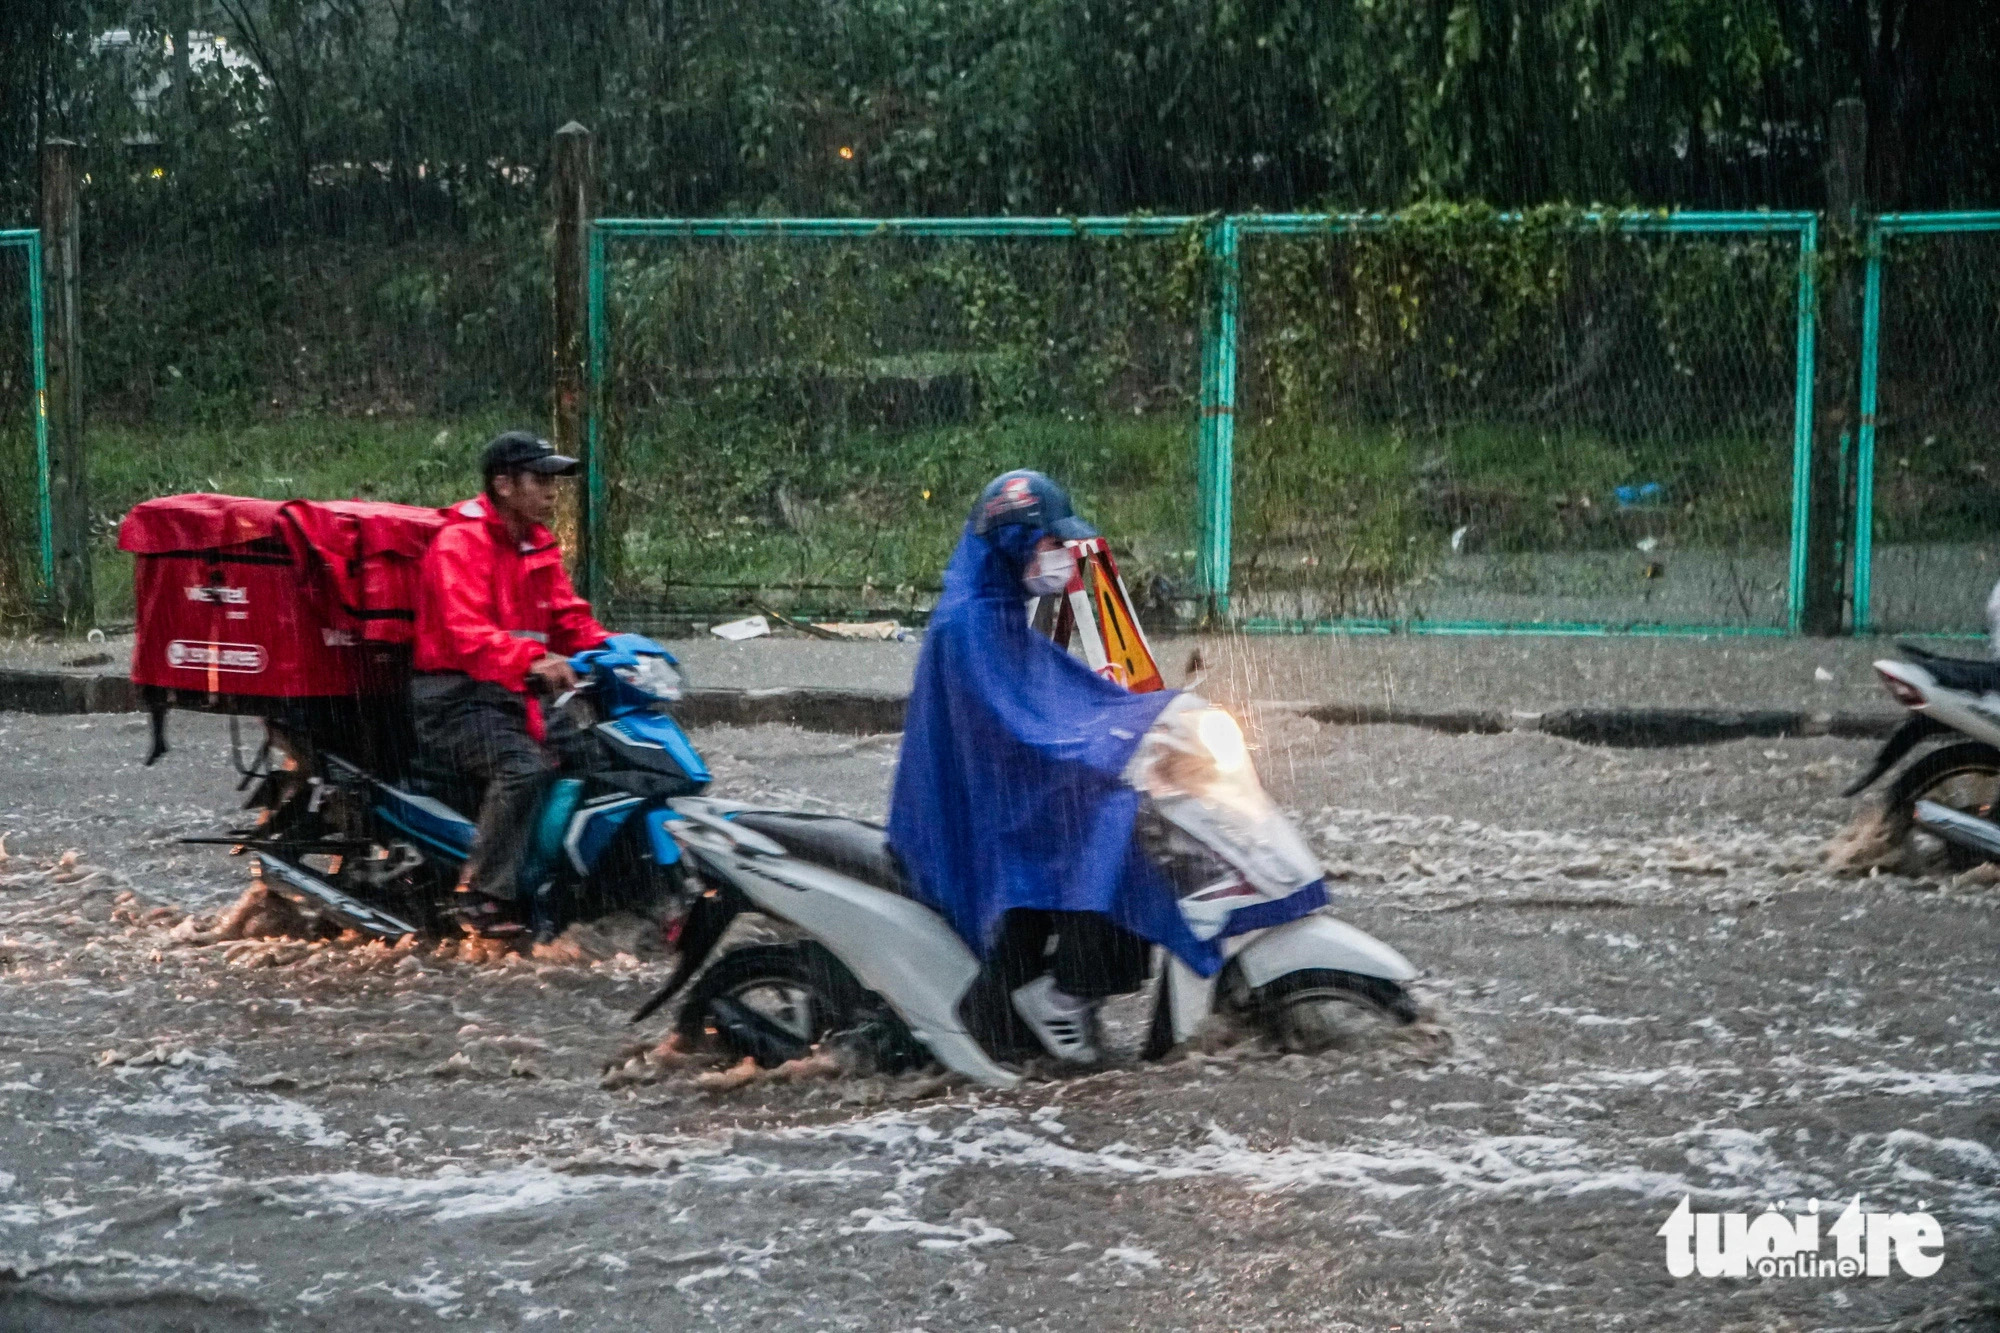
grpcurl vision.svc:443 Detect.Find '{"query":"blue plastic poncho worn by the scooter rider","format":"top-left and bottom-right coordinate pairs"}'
top-left (888, 524), bottom-right (1222, 975)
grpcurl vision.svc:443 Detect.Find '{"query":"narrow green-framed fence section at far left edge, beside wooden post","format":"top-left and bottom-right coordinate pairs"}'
top-left (0, 230), bottom-right (52, 614)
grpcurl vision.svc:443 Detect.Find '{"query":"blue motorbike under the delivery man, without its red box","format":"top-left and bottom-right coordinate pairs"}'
top-left (211, 634), bottom-right (710, 941)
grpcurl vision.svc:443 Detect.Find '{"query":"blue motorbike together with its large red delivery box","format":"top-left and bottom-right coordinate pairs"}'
top-left (118, 494), bottom-right (708, 939)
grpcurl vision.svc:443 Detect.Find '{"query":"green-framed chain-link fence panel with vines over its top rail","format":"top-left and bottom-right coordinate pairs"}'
top-left (1230, 208), bottom-right (1812, 632)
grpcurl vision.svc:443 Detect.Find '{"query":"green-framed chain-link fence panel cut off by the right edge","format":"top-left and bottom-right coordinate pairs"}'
top-left (1854, 212), bottom-right (2000, 634)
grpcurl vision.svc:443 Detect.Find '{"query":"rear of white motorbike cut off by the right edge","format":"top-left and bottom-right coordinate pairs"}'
top-left (1840, 642), bottom-right (2000, 873)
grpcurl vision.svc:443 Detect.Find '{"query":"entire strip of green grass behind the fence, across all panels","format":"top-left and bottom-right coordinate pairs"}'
top-left (58, 406), bottom-right (1816, 622)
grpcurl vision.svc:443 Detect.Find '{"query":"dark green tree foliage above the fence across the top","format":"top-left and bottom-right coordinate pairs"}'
top-left (0, 0), bottom-right (2000, 236)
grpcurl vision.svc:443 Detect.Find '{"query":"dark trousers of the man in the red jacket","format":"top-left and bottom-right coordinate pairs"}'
top-left (410, 673), bottom-right (590, 901)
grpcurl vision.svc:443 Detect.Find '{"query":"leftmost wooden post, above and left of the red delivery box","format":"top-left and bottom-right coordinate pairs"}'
top-left (42, 138), bottom-right (96, 628)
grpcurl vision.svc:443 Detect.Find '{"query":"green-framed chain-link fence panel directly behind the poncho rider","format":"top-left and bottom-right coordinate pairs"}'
top-left (590, 218), bottom-right (1204, 620)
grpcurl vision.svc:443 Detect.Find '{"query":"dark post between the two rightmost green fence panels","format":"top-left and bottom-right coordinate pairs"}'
top-left (1800, 98), bottom-right (1868, 634)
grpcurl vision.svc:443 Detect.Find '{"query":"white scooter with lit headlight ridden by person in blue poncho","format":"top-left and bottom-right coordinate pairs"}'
top-left (632, 695), bottom-right (1416, 1087)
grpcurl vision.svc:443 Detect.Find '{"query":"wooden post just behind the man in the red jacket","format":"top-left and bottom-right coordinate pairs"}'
top-left (550, 120), bottom-right (604, 596)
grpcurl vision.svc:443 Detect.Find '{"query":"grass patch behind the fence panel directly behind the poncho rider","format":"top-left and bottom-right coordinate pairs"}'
top-left (614, 412), bottom-right (1194, 612)
